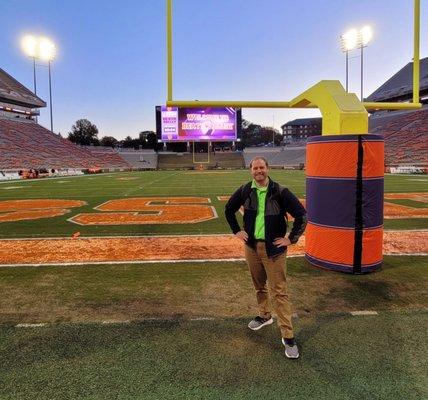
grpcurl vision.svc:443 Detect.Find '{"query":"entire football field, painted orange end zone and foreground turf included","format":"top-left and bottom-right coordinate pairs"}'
top-left (0, 170), bottom-right (428, 399)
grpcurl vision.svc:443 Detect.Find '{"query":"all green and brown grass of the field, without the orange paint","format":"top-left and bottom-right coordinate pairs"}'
top-left (0, 170), bottom-right (428, 400)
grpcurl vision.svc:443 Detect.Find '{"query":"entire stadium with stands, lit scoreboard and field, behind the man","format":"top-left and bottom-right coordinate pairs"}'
top-left (0, 1), bottom-right (428, 399)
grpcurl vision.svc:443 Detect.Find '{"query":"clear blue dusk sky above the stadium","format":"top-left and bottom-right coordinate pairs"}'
top-left (0, 0), bottom-right (428, 139)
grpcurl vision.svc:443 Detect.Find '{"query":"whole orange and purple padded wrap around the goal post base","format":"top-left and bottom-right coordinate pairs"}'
top-left (305, 134), bottom-right (384, 274)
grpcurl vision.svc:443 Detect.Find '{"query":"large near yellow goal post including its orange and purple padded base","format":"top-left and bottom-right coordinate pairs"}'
top-left (166, 0), bottom-right (422, 274)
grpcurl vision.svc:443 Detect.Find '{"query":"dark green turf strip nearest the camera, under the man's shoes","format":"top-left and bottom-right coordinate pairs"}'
top-left (0, 312), bottom-right (428, 400)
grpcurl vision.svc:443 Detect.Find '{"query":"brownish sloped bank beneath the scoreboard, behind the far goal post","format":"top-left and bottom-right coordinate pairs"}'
top-left (158, 152), bottom-right (245, 169)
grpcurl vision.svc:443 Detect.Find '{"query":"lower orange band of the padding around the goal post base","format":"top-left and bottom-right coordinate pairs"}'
top-left (305, 222), bottom-right (383, 268)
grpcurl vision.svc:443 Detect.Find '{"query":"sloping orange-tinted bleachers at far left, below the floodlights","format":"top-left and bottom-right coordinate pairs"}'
top-left (0, 118), bottom-right (130, 170)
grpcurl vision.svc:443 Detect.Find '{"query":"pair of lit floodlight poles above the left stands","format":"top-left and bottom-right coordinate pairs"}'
top-left (21, 35), bottom-right (56, 132)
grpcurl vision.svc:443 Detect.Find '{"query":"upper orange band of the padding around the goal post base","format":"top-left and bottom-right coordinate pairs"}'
top-left (306, 140), bottom-right (384, 178)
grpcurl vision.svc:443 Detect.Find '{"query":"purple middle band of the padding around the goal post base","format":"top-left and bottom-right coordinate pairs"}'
top-left (306, 177), bottom-right (383, 228)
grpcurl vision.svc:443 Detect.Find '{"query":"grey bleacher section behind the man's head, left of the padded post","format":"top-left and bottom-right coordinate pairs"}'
top-left (244, 147), bottom-right (306, 168)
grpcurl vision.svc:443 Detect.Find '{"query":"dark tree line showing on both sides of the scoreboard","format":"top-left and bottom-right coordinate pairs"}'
top-left (68, 119), bottom-right (283, 151)
